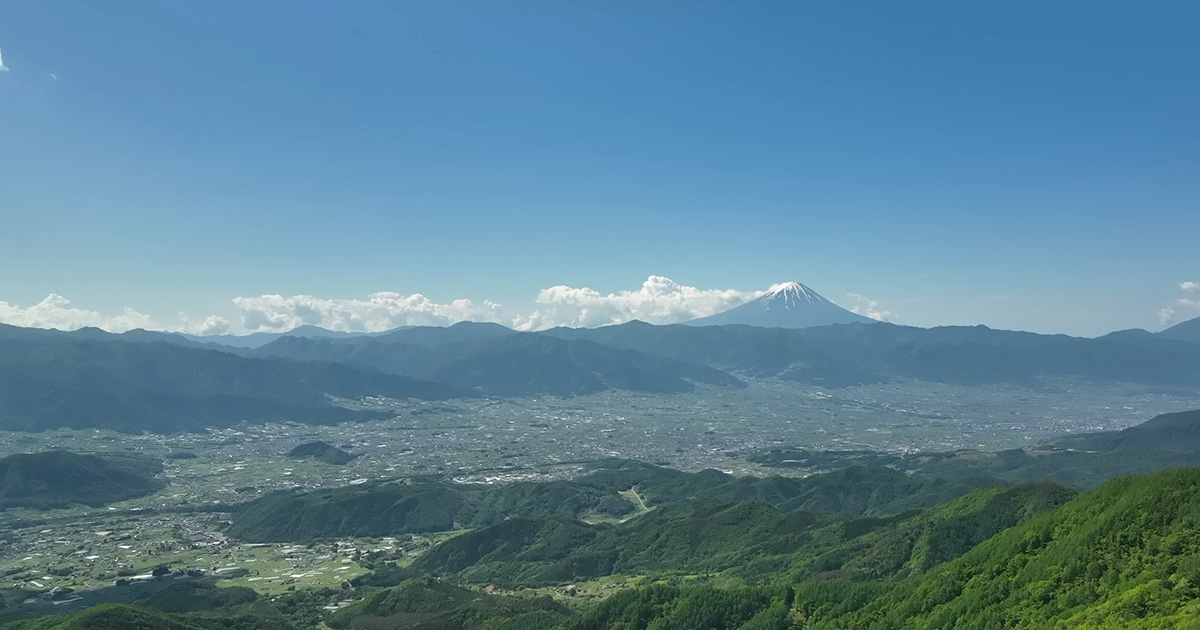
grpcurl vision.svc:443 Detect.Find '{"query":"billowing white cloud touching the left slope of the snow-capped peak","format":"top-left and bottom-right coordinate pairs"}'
top-left (514, 276), bottom-right (763, 330)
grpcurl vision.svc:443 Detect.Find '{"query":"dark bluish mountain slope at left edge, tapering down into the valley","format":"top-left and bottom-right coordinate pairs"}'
top-left (0, 334), bottom-right (464, 432)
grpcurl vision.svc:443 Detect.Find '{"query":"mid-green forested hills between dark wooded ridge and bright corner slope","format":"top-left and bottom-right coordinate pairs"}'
top-left (410, 484), bottom-right (1074, 588)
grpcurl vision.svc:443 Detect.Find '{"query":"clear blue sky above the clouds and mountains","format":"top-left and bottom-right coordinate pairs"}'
top-left (0, 0), bottom-right (1200, 335)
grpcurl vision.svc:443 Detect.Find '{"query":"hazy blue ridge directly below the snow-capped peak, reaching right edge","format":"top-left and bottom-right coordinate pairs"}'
top-left (542, 322), bottom-right (1200, 386)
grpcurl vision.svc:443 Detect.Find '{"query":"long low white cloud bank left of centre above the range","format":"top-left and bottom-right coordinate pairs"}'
top-left (233, 292), bottom-right (502, 332)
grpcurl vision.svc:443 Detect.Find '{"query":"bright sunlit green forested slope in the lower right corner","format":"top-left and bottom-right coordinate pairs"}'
top-left (797, 469), bottom-right (1200, 630)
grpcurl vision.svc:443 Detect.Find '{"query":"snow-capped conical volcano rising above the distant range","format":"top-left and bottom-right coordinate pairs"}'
top-left (684, 282), bottom-right (875, 328)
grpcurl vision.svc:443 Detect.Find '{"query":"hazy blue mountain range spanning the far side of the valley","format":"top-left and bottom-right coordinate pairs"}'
top-left (0, 309), bottom-right (1200, 432)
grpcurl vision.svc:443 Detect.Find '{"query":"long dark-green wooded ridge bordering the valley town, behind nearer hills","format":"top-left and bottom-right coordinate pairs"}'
top-left (229, 460), bottom-right (1000, 541)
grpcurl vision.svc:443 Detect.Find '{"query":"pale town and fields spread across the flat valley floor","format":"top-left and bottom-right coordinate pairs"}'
top-left (0, 380), bottom-right (1195, 610)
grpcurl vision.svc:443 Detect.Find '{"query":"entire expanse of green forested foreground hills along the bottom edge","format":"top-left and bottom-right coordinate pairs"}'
top-left (4, 467), bottom-right (1200, 630)
